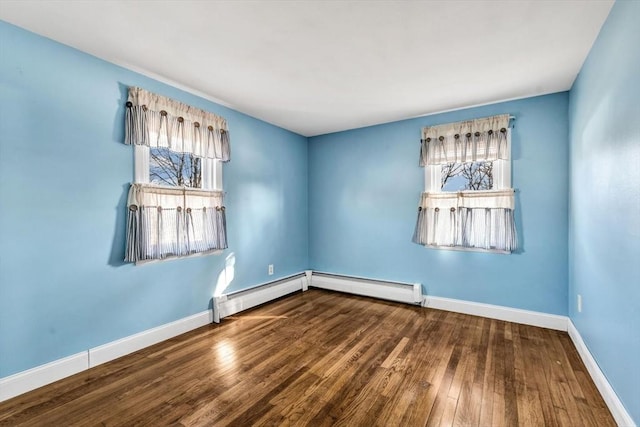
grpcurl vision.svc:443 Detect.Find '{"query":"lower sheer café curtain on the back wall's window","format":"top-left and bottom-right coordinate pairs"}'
top-left (413, 189), bottom-right (518, 252)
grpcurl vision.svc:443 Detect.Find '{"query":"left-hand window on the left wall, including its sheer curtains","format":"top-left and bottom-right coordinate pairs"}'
top-left (125, 87), bottom-right (230, 263)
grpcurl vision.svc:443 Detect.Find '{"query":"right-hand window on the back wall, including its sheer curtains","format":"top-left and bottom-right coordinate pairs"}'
top-left (413, 115), bottom-right (517, 253)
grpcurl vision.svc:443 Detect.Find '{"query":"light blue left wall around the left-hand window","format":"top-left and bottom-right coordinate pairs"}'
top-left (0, 22), bottom-right (308, 377)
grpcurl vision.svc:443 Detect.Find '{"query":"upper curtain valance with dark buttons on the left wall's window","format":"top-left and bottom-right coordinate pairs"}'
top-left (125, 87), bottom-right (231, 162)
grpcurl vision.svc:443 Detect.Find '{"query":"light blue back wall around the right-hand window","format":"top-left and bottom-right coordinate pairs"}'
top-left (309, 92), bottom-right (568, 315)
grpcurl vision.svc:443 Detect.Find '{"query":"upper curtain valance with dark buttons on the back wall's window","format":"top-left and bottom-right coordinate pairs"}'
top-left (420, 114), bottom-right (509, 167)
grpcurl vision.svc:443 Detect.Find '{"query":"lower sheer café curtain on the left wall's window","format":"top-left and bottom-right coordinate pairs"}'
top-left (125, 184), bottom-right (227, 262)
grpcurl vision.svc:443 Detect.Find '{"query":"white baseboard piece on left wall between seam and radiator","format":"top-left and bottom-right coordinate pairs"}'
top-left (89, 310), bottom-right (213, 368)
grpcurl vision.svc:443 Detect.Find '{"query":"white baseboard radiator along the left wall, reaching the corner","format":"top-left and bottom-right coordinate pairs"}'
top-left (213, 271), bottom-right (311, 323)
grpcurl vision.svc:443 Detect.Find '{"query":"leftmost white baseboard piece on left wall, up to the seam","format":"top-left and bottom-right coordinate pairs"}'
top-left (0, 351), bottom-right (89, 402)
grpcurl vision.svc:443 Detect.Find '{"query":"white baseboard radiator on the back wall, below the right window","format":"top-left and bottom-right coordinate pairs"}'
top-left (309, 271), bottom-right (424, 305)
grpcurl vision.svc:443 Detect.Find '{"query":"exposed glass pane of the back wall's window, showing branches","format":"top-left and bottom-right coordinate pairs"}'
top-left (440, 162), bottom-right (493, 191)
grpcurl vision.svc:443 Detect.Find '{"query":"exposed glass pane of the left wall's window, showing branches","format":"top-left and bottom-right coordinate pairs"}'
top-left (149, 148), bottom-right (202, 188)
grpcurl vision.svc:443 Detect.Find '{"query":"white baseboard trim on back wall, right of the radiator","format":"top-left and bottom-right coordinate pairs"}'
top-left (423, 296), bottom-right (568, 332)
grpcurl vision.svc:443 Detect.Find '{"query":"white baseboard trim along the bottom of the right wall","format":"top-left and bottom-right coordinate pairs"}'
top-left (568, 319), bottom-right (636, 427)
